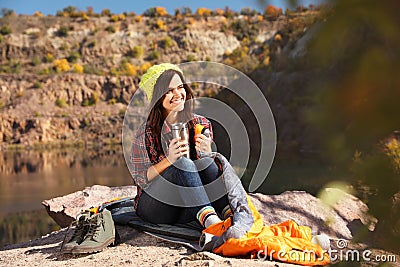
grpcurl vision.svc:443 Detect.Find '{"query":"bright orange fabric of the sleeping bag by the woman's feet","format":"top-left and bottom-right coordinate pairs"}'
top-left (203, 196), bottom-right (330, 266)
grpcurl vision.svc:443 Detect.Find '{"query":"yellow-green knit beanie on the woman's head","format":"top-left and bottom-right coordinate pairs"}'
top-left (139, 63), bottom-right (183, 101)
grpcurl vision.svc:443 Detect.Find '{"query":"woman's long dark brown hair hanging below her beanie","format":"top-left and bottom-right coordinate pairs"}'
top-left (146, 70), bottom-right (194, 151)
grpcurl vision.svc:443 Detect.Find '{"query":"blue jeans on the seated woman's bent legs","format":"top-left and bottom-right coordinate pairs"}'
top-left (136, 157), bottom-right (229, 224)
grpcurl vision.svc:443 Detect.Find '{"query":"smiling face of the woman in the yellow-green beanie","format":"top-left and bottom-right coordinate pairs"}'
top-left (162, 74), bottom-right (186, 115)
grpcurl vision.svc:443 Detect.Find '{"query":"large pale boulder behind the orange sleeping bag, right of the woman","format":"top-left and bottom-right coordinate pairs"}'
top-left (250, 188), bottom-right (376, 239)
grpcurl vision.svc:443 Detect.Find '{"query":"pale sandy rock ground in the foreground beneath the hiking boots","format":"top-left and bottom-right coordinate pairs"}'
top-left (0, 226), bottom-right (304, 267)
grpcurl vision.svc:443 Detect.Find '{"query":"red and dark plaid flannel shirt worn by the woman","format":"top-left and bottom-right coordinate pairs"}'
top-left (129, 114), bottom-right (213, 206)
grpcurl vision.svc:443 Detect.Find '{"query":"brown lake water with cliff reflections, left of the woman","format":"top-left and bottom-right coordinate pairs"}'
top-left (0, 147), bottom-right (131, 247)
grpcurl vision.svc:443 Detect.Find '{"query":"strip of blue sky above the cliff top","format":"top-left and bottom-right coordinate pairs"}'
top-left (0, 0), bottom-right (319, 15)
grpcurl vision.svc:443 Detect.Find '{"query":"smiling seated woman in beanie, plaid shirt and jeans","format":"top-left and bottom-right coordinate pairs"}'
top-left (131, 63), bottom-right (231, 228)
